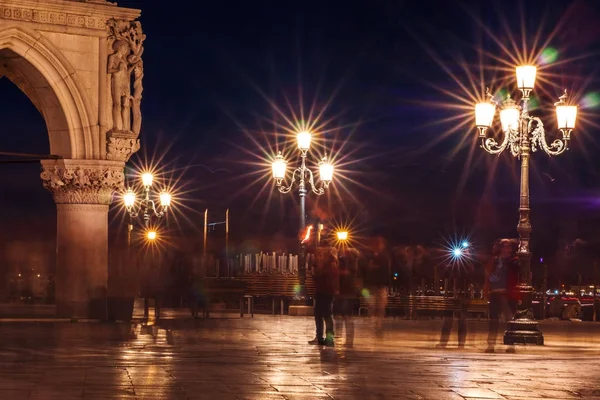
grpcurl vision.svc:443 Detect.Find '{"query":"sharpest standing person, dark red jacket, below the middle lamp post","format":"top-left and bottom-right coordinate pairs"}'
top-left (308, 247), bottom-right (340, 346)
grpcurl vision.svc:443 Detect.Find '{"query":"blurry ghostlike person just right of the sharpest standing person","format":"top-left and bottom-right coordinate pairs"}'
top-left (334, 249), bottom-right (360, 346)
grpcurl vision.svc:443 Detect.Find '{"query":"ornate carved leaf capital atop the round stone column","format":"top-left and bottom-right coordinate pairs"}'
top-left (40, 160), bottom-right (125, 205)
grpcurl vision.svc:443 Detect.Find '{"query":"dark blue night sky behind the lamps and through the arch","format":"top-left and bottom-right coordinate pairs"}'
top-left (0, 0), bottom-right (600, 253)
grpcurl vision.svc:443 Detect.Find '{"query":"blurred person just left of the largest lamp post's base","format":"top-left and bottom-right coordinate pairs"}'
top-left (484, 239), bottom-right (519, 353)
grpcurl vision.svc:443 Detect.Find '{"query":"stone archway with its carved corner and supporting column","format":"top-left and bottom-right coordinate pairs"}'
top-left (0, 0), bottom-right (145, 319)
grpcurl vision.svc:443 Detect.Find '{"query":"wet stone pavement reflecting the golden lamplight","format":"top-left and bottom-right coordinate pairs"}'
top-left (0, 315), bottom-right (600, 400)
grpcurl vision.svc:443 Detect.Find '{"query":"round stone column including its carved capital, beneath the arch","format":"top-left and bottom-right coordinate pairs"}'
top-left (41, 160), bottom-right (124, 320)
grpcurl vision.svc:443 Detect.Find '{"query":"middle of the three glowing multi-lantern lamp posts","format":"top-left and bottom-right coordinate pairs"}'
top-left (272, 131), bottom-right (333, 290)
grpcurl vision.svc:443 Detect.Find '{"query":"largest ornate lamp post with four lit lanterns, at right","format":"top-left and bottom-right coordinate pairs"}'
top-left (475, 65), bottom-right (577, 345)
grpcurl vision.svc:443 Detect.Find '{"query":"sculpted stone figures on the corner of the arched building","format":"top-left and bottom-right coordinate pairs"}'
top-left (107, 19), bottom-right (146, 161)
